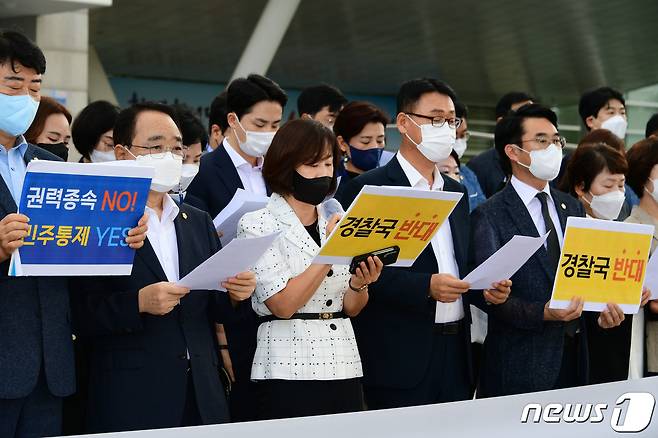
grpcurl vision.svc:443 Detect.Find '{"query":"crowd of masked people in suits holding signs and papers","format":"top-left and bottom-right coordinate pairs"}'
top-left (0, 31), bottom-right (658, 437)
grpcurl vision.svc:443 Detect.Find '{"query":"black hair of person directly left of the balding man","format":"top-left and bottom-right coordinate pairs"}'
top-left (71, 100), bottom-right (119, 159)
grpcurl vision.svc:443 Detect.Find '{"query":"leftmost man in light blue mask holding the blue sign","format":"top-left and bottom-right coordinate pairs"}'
top-left (0, 32), bottom-right (146, 437)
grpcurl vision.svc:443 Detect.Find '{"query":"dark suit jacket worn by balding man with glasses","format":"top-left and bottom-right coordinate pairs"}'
top-left (72, 204), bottom-right (232, 432)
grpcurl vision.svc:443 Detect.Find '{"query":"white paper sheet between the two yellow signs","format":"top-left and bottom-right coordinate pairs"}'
top-left (464, 232), bottom-right (550, 289)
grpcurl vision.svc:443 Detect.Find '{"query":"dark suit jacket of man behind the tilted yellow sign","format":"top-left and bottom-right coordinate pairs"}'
top-left (340, 159), bottom-right (472, 388)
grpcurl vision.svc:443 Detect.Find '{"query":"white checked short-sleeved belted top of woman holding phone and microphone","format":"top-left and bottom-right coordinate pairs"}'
top-left (238, 193), bottom-right (363, 382)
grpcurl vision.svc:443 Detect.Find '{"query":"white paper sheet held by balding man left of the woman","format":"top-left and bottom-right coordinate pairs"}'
top-left (176, 233), bottom-right (281, 290)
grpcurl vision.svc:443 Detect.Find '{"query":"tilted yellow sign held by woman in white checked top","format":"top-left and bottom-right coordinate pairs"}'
top-left (314, 186), bottom-right (462, 266)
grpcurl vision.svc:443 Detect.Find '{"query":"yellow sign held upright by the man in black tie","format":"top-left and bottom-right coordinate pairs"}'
top-left (550, 217), bottom-right (653, 313)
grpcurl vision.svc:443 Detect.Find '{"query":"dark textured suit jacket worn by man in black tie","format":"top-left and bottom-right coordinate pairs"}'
top-left (471, 184), bottom-right (587, 397)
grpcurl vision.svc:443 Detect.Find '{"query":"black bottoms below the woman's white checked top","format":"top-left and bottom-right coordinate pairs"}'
top-left (258, 379), bottom-right (363, 420)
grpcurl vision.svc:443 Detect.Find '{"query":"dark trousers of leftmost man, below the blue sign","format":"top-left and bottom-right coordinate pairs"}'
top-left (0, 371), bottom-right (62, 438)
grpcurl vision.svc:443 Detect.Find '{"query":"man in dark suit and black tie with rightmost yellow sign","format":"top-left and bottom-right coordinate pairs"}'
top-left (471, 104), bottom-right (624, 397)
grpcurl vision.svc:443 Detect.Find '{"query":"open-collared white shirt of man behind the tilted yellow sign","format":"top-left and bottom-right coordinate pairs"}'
top-left (396, 152), bottom-right (464, 323)
